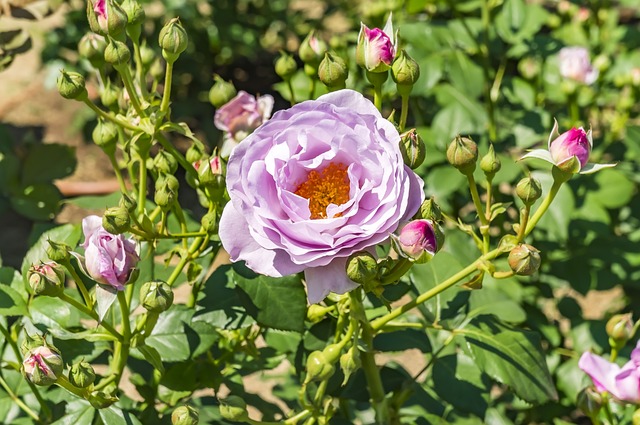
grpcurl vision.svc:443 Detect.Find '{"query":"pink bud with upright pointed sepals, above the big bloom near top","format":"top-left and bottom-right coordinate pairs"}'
top-left (356, 15), bottom-right (397, 72)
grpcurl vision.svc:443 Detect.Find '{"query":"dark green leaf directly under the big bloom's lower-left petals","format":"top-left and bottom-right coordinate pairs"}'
top-left (233, 264), bottom-right (307, 332)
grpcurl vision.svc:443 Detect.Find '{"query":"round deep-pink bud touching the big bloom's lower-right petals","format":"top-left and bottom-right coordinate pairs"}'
top-left (395, 219), bottom-right (438, 263)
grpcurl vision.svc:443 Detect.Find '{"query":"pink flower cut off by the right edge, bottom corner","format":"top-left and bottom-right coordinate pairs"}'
top-left (578, 341), bottom-right (640, 404)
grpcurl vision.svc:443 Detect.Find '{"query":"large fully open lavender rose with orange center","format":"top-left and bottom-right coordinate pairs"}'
top-left (220, 90), bottom-right (424, 303)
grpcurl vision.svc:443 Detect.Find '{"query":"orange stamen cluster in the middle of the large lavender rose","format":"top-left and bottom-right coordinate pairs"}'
top-left (294, 163), bottom-right (350, 219)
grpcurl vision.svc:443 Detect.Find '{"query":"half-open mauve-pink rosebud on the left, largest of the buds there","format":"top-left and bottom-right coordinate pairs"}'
top-left (82, 215), bottom-right (140, 291)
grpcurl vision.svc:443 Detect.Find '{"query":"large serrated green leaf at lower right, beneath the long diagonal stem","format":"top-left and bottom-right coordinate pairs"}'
top-left (456, 316), bottom-right (558, 404)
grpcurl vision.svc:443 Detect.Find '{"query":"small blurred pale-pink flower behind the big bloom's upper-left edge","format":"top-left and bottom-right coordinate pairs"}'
top-left (213, 90), bottom-right (273, 158)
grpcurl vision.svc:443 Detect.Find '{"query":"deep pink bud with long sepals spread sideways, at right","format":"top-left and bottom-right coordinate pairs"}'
top-left (521, 120), bottom-right (615, 174)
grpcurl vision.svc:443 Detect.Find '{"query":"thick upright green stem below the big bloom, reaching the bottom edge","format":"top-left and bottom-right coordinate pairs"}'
top-left (349, 290), bottom-right (390, 425)
